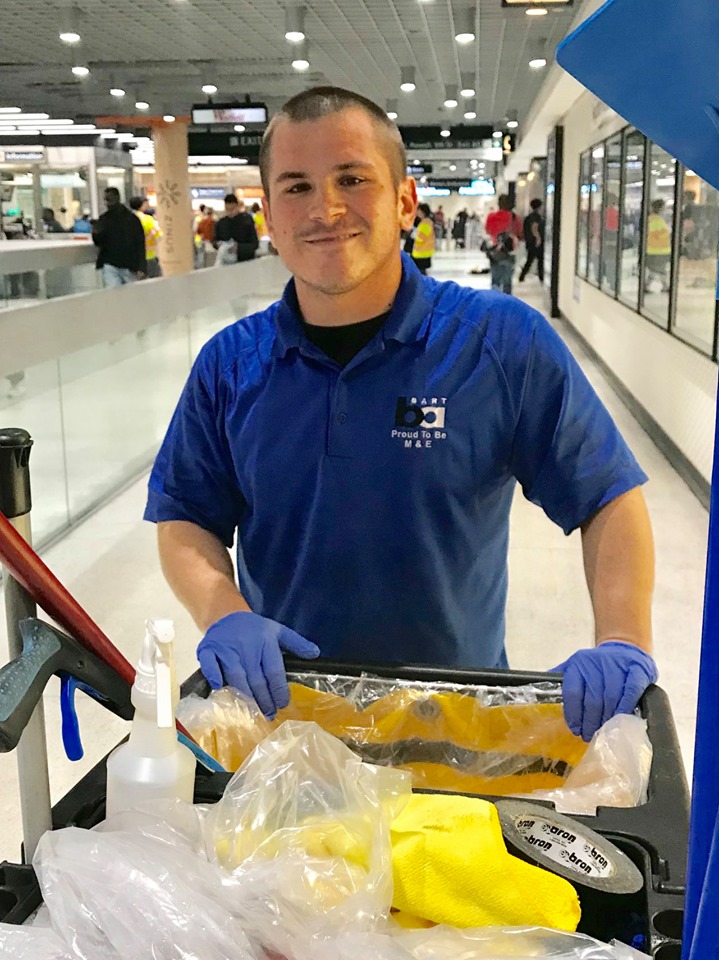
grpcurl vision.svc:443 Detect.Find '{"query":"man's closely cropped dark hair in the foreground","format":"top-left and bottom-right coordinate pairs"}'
top-left (260, 86), bottom-right (407, 197)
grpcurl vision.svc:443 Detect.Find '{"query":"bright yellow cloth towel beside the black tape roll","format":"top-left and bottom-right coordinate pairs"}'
top-left (391, 794), bottom-right (581, 932)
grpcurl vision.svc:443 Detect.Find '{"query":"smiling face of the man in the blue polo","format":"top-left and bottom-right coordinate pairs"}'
top-left (263, 107), bottom-right (417, 295)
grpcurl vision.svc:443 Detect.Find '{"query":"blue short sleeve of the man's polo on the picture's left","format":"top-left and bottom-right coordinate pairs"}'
top-left (145, 341), bottom-right (244, 547)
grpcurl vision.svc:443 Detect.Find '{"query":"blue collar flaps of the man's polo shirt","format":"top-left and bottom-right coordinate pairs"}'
top-left (272, 253), bottom-right (434, 357)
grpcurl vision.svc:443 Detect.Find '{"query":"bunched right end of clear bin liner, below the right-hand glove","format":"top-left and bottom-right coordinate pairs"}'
top-left (531, 714), bottom-right (653, 816)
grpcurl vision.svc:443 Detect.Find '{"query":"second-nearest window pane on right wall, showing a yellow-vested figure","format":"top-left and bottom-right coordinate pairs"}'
top-left (642, 143), bottom-right (676, 327)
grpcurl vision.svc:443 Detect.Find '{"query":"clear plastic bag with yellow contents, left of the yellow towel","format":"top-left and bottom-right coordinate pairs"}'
top-left (207, 721), bottom-right (411, 935)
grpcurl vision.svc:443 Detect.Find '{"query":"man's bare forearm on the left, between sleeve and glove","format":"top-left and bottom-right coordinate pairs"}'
top-left (157, 520), bottom-right (250, 632)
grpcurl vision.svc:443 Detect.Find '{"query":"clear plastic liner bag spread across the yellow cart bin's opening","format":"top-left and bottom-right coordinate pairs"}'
top-left (178, 673), bottom-right (651, 813)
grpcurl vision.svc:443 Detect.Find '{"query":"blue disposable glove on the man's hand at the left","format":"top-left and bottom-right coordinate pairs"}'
top-left (197, 611), bottom-right (320, 720)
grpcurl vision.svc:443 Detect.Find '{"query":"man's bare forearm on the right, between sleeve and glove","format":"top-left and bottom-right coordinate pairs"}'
top-left (582, 487), bottom-right (654, 650)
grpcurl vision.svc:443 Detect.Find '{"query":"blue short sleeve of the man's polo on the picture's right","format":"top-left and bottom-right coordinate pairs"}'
top-left (510, 311), bottom-right (647, 534)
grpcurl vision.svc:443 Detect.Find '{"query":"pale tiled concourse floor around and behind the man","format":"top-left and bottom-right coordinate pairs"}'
top-left (0, 254), bottom-right (707, 860)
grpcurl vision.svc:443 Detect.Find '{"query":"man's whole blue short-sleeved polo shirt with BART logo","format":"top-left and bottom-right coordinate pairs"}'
top-left (145, 256), bottom-right (646, 667)
